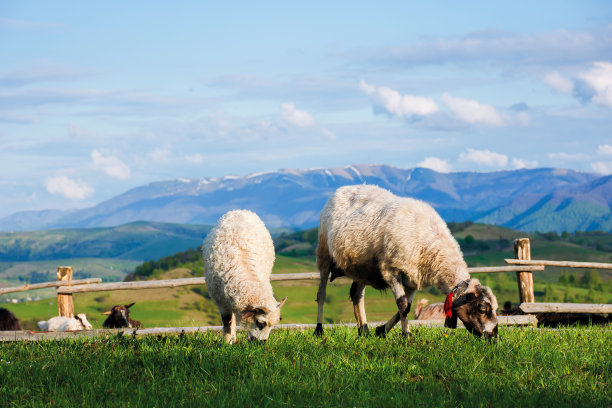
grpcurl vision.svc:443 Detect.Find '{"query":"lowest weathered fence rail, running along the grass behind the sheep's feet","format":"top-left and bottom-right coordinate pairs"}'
top-left (0, 316), bottom-right (537, 341)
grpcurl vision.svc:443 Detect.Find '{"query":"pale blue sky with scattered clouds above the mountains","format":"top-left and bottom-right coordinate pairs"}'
top-left (0, 1), bottom-right (612, 217)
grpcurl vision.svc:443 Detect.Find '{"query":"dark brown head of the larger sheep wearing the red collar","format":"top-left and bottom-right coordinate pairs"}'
top-left (445, 279), bottom-right (497, 338)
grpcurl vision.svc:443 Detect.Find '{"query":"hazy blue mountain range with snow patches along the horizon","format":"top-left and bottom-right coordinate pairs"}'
top-left (0, 164), bottom-right (612, 232)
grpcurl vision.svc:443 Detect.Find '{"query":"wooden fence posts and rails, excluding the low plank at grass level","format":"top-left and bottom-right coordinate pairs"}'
top-left (0, 238), bottom-right (612, 332)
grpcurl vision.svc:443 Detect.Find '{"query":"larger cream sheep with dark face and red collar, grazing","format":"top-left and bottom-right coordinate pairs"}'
top-left (315, 185), bottom-right (497, 337)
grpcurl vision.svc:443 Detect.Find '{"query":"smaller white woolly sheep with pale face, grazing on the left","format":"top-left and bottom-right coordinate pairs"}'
top-left (202, 210), bottom-right (287, 344)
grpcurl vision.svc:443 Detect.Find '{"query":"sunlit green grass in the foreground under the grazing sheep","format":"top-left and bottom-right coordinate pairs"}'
top-left (0, 327), bottom-right (612, 407)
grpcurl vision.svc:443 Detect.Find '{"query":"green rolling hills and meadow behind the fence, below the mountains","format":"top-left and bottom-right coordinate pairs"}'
top-left (0, 222), bottom-right (612, 330)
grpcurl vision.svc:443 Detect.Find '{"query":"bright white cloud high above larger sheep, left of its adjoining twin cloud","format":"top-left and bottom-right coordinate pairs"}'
top-left (359, 80), bottom-right (439, 118)
